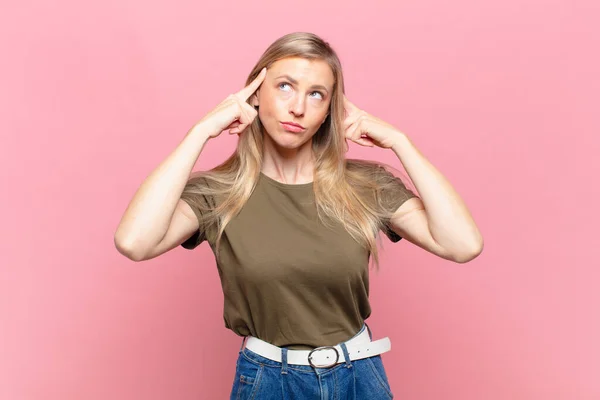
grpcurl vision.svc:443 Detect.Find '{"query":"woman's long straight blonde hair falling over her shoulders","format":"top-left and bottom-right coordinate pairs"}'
top-left (182, 32), bottom-right (418, 268)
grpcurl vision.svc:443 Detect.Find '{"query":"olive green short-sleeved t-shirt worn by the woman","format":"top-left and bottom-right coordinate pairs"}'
top-left (182, 167), bottom-right (415, 349)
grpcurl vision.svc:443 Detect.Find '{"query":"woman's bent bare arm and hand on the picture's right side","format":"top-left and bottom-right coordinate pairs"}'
top-left (344, 97), bottom-right (483, 263)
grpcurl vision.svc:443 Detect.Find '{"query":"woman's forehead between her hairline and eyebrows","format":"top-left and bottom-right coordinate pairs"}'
top-left (267, 57), bottom-right (334, 88)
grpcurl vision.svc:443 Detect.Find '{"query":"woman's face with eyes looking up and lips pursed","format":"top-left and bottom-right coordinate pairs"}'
top-left (255, 57), bottom-right (334, 148)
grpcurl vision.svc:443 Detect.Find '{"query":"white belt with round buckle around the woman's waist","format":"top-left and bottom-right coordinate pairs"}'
top-left (241, 329), bottom-right (392, 368)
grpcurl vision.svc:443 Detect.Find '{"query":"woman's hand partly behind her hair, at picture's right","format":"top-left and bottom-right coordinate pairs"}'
top-left (344, 96), bottom-right (402, 149)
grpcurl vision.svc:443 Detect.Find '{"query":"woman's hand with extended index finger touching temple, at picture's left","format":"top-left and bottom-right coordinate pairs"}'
top-left (196, 68), bottom-right (267, 138)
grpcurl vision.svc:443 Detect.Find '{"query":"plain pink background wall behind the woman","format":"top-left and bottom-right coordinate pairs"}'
top-left (0, 0), bottom-right (600, 400)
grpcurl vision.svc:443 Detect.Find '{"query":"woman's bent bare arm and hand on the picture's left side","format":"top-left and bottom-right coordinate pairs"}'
top-left (114, 68), bottom-right (267, 260)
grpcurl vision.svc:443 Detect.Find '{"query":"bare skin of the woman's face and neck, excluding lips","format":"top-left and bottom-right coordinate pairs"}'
top-left (252, 57), bottom-right (335, 184)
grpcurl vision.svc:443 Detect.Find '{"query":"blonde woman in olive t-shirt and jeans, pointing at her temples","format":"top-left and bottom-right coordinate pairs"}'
top-left (115, 33), bottom-right (483, 400)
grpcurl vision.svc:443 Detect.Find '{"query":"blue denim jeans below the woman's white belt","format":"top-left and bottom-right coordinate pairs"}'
top-left (230, 324), bottom-right (394, 400)
